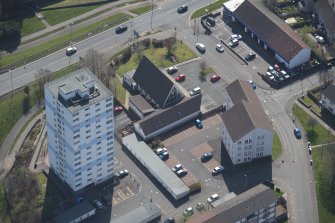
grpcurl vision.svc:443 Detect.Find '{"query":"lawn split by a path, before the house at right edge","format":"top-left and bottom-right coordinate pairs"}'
top-left (293, 105), bottom-right (335, 145)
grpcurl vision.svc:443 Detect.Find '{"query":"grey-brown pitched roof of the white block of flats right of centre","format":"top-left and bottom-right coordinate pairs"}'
top-left (222, 80), bottom-right (273, 142)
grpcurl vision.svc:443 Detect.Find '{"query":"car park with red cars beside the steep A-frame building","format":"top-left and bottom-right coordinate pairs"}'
top-left (171, 60), bottom-right (228, 111)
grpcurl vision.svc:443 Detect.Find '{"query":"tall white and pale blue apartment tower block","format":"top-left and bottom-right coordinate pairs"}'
top-left (44, 68), bottom-right (115, 191)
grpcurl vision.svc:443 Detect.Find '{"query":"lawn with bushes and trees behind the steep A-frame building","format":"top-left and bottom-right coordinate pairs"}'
top-left (116, 41), bottom-right (197, 77)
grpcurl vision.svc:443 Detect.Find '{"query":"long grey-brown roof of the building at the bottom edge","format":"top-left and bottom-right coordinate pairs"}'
top-left (188, 184), bottom-right (277, 223)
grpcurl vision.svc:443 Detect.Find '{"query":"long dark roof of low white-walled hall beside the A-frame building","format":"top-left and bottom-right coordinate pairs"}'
top-left (138, 94), bottom-right (201, 135)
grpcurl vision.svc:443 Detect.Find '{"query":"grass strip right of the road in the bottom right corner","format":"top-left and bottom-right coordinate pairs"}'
top-left (313, 147), bottom-right (335, 223)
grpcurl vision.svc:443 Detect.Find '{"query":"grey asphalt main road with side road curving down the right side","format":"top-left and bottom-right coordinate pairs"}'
top-left (0, 0), bottom-right (318, 223)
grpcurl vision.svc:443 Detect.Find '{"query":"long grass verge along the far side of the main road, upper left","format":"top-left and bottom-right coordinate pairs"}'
top-left (0, 13), bottom-right (132, 67)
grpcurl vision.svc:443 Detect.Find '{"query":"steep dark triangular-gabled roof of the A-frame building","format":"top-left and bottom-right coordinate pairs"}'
top-left (133, 56), bottom-right (174, 107)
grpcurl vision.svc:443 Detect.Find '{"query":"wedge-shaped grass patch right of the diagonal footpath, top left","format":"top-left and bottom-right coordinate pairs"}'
top-left (41, 4), bottom-right (102, 26)
